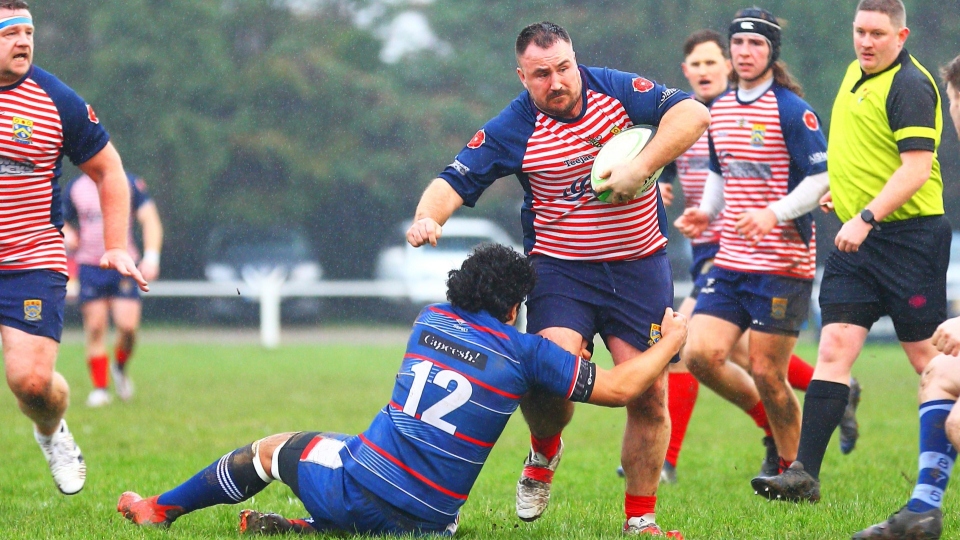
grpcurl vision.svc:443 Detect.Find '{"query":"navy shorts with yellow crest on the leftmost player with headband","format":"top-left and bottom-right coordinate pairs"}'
top-left (0, 270), bottom-right (67, 342)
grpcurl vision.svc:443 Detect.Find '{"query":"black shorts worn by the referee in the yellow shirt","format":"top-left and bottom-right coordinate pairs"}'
top-left (820, 216), bottom-right (952, 343)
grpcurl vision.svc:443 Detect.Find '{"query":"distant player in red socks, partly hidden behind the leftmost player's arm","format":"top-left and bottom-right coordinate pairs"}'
top-left (63, 174), bottom-right (163, 407)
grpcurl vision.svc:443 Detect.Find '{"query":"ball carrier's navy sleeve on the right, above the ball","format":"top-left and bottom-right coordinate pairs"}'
top-left (584, 68), bottom-right (690, 126)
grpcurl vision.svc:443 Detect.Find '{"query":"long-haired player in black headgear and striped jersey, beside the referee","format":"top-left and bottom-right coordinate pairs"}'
top-left (676, 8), bottom-right (827, 490)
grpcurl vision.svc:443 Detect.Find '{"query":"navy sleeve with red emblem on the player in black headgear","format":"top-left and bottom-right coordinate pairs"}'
top-left (775, 86), bottom-right (827, 189)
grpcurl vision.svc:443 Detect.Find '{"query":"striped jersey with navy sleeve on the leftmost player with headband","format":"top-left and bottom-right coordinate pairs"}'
top-left (0, 66), bottom-right (109, 274)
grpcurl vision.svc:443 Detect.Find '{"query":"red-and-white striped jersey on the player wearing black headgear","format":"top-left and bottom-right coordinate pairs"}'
top-left (707, 83), bottom-right (827, 279)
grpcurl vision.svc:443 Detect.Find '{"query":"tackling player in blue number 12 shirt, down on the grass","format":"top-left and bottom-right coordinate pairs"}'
top-left (117, 244), bottom-right (686, 538)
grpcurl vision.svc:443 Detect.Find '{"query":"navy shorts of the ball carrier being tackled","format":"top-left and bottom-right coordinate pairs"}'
top-left (527, 250), bottom-right (679, 361)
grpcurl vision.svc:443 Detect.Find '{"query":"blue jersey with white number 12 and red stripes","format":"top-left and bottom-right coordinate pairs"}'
top-left (340, 304), bottom-right (596, 523)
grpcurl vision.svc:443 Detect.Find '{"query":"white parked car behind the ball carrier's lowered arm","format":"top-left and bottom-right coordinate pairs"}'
top-left (374, 218), bottom-right (523, 308)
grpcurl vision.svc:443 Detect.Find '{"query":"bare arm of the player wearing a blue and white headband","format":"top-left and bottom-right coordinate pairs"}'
top-left (78, 143), bottom-right (149, 291)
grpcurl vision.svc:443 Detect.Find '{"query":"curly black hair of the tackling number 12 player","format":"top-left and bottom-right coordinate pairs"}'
top-left (447, 244), bottom-right (537, 322)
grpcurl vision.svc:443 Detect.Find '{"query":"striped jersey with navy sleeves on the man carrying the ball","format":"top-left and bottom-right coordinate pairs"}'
top-left (440, 66), bottom-right (690, 261)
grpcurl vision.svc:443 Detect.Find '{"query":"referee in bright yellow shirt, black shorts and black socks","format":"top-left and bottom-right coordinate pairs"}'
top-left (754, 0), bottom-right (951, 502)
